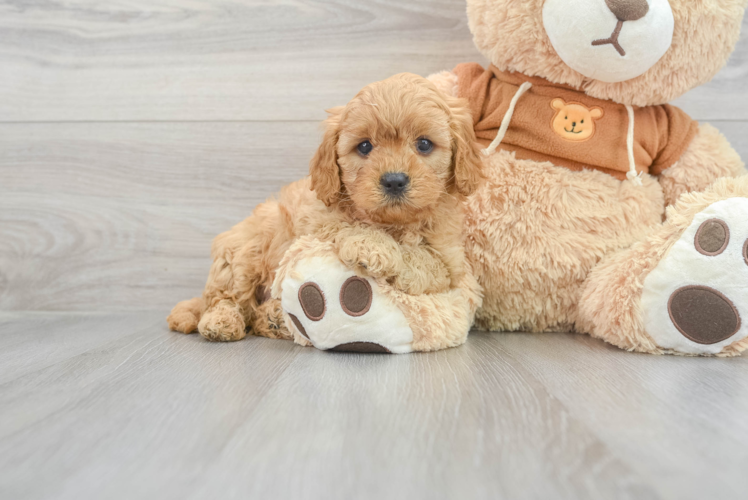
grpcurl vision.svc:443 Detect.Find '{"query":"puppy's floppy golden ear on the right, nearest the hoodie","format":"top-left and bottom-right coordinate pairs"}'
top-left (447, 97), bottom-right (484, 196)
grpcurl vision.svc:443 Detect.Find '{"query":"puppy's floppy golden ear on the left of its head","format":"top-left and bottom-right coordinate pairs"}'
top-left (309, 107), bottom-right (344, 207)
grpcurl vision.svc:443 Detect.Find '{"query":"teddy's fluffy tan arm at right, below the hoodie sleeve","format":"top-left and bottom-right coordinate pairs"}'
top-left (660, 123), bottom-right (748, 205)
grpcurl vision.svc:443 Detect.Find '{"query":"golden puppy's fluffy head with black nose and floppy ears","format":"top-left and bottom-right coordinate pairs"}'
top-left (310, 73), bottom-right (482, 224)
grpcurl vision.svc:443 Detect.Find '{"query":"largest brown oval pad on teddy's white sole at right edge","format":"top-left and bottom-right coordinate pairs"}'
top-left (668, 286), bottom-right (741, 345)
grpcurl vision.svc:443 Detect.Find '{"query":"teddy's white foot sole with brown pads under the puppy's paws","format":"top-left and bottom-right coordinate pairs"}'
top-left (282, 255), bottom-right (413, 354)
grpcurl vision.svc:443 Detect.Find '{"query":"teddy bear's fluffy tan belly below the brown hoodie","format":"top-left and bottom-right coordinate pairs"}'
top-left (466, 151), bottom-right (664, 332)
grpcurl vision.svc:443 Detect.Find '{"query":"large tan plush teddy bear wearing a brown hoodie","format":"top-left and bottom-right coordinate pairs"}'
top-left (276, 0), bottom-right (748, 356)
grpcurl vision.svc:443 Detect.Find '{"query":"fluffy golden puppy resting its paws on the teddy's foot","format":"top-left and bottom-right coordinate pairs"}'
top-left (167, 74), bottom-right (482, 341)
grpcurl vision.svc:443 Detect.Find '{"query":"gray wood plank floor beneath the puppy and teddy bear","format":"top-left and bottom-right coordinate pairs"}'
top-left (0, 313), bottom-right (748, 499)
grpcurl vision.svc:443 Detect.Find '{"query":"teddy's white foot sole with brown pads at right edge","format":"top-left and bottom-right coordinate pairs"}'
top-left (641, 198), bottom-right (748, 355)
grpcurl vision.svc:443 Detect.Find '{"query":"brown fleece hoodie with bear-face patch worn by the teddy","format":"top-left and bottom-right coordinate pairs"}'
top-left (455, 63), bottom-right (698, 179)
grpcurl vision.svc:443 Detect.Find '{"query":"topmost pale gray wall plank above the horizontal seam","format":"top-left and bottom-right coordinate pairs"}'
top-left (0, 0), bottom-right (748, 122)
